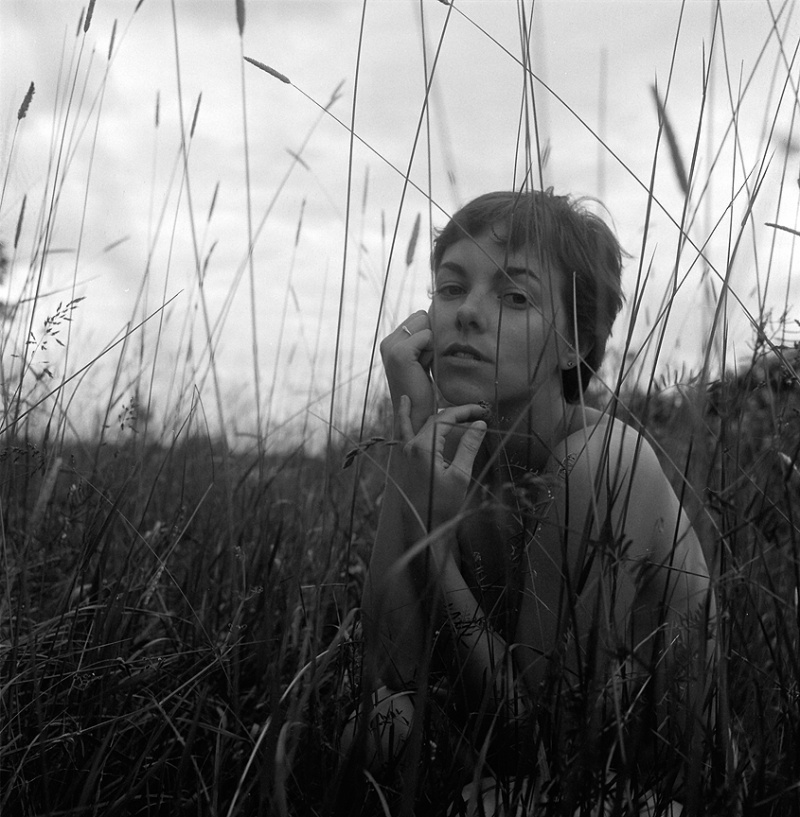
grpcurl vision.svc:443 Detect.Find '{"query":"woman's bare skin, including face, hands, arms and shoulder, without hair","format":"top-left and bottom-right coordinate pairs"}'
top-left (362, 232), bottom-right (713, 796)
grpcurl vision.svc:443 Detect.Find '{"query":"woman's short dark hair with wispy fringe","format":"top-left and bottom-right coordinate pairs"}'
top-left (431, 188), bottom-right (624, 403)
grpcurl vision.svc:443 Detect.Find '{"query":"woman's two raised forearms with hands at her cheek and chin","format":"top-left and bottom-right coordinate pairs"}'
top-left (362, 312), bottom-right (524, 709)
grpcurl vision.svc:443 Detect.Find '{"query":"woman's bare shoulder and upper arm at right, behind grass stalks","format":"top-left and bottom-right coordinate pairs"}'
top-left (515, 423), bottom-right (715, 756)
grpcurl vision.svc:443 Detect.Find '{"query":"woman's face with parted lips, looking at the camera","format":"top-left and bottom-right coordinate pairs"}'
top-left (430, 232), bottom-right (574, 416)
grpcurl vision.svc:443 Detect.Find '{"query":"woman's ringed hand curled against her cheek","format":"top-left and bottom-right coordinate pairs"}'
top-left (381, 309), bottom-right (435, 434)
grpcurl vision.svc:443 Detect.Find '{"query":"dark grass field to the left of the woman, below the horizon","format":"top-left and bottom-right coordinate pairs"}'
top-left (0, 430), bottom-right (375, 815)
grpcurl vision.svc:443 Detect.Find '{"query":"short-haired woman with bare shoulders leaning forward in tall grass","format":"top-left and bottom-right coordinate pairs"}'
top-left (352, 191), bottom-right (714, 814)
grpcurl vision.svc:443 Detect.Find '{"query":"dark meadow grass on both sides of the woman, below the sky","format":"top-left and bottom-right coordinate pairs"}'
top-left (0, 353), bottom-right (800, 817)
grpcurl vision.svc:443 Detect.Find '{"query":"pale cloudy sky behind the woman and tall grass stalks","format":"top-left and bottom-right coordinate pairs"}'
top-left (0, 0), bottom-right (800, 442)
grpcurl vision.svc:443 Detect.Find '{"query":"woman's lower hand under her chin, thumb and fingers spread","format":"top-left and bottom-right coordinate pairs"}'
top-left (397, 395), bottom-right (486, 532)
